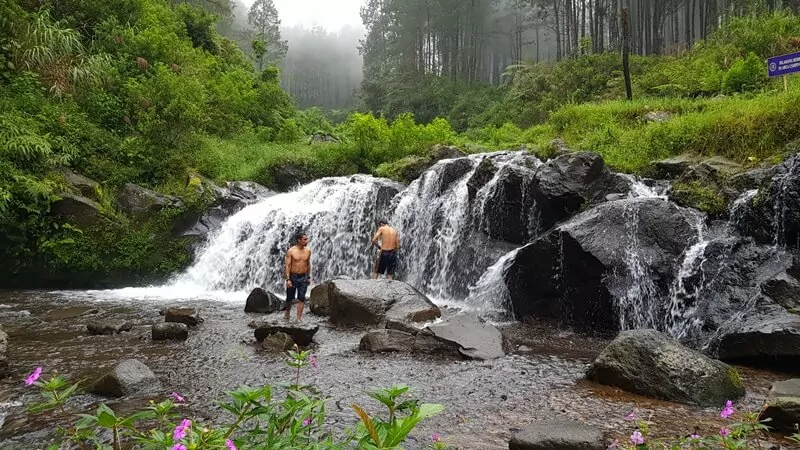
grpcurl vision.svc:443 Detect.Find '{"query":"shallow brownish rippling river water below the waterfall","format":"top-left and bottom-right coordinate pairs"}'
top-left (0, 291), bottom-right (790, 449)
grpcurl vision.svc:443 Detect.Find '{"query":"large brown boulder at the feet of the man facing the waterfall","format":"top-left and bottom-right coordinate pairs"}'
top-left (328, 280), bottom-right (442, 326)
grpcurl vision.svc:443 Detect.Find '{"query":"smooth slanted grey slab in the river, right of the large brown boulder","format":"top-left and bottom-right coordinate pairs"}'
top-left (426, 314), bottom-right (505, 360)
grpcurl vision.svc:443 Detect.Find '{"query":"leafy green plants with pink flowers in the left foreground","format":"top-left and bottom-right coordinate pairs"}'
top-left (21, 346), bottom-right (447, 450)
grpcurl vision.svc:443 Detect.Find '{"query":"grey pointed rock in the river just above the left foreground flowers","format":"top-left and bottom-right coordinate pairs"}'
top-left (90, 359), bottom-right (161, 397)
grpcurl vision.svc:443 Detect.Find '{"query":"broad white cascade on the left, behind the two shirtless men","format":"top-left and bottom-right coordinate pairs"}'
top-left (174, 175), bottom-right (396, 292)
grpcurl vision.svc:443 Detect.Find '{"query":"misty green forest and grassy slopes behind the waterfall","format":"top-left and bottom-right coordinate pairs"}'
top-left (0, 0), bottom-right (800, 286)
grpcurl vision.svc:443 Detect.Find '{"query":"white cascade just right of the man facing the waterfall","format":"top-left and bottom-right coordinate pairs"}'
top-left (392, 152), bottom-right (541, 306)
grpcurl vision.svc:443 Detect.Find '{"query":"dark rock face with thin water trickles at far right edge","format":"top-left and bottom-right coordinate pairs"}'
top-left (735, 154), bottom-right (800, 248)
